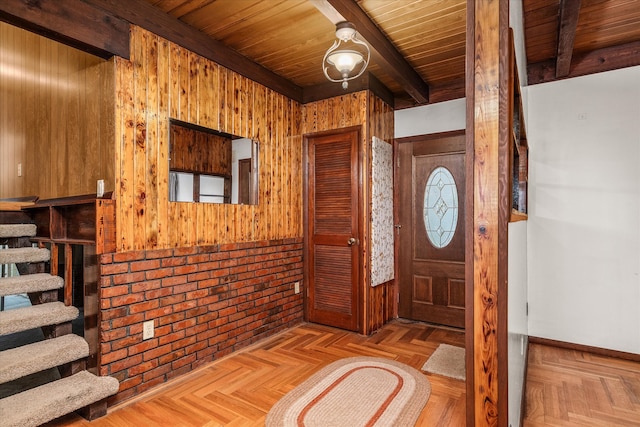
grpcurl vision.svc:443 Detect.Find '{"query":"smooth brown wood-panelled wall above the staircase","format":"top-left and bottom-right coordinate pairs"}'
top-left (0, 22), bottom-right (115, 199)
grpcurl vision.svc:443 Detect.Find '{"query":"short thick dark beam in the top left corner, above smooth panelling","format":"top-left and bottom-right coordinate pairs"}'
top-left (0, 0), bottom-right (129, 58)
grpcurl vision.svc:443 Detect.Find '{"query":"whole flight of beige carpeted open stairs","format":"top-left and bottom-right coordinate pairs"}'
top-left (0, 224), bottom-right (119, 427)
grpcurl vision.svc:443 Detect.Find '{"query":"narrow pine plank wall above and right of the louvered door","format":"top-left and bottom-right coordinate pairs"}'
top-left (302, 91), bottom-right (397, 334)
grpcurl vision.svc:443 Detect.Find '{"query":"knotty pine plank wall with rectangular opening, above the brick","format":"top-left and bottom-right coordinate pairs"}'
top-left (115, 26), bottom-right (302, 252)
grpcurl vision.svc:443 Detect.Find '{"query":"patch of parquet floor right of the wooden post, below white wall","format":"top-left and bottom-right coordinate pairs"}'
top-left (524, 344), bottom-right (640, 427)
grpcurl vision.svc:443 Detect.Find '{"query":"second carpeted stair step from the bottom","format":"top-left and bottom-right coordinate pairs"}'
top-left (0, 334), bottom-right (89, 384)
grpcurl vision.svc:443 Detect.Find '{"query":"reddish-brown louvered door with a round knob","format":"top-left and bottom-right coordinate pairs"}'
top-left (305, 130), bottom-right (360, 331)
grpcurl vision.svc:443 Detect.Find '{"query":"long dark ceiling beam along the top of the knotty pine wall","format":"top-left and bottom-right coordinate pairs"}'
top-left (84, 0), bottom-right (302, 102)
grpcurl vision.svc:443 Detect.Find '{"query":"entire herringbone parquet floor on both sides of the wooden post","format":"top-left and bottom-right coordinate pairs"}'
top-left (42, 320), bottom-right (640, 427)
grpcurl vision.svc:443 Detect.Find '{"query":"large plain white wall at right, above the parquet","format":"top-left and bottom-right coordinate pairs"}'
top-left (527, 67), bottom-right (640, 353)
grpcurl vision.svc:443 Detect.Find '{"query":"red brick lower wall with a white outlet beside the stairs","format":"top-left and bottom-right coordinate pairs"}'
top-left (100, 239), bottom-right (303, 404)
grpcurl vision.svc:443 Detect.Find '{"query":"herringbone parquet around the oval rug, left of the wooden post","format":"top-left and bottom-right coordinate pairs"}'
top-left (49, 320), bottom-right (465, 427)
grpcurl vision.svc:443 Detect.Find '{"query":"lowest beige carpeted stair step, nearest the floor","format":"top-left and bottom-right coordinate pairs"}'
top-left (0, 371), bottom-right (120, 427)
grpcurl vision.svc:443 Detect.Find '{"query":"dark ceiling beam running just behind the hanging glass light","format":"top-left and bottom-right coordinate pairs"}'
top-left (314, 0), bottom-right (429, 104)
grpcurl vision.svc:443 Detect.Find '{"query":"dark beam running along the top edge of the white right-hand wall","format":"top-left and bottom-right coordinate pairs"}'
top-left (527, 42), bottom-right (640, 85)
